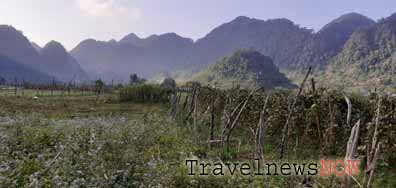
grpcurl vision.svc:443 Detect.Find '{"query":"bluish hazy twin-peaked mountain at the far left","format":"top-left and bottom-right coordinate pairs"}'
top-left (0, 25), bottom-right (89, 82)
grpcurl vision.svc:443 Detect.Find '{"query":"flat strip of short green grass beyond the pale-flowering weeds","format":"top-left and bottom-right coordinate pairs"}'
top-left (0, 94), bottom-right (166, 119)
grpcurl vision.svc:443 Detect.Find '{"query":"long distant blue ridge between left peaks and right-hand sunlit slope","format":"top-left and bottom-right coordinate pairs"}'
top-left (71, 13), bottom-right (375, 82)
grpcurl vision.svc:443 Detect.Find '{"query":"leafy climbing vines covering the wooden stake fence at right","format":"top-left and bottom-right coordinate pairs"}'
top-left (172, 87), bottom-right (396, 187)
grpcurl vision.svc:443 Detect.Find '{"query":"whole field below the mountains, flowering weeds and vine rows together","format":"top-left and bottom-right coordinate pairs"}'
top-left (0, 88), bottom-right (396, 188)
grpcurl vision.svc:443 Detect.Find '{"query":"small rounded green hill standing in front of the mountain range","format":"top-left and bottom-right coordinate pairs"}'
top-left (193, 50), bottom-right (293, 89)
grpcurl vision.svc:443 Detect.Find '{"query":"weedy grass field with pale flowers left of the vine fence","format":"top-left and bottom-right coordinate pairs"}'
top-left (0, 95), bottom-right (298, 187)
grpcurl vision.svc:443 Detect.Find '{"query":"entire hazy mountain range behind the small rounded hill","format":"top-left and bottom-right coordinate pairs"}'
top-left (0, 13), bottom-right (396, 88)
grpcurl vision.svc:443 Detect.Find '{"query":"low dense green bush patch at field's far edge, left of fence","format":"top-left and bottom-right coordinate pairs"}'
top-left (120, 84), bottom-right (171, 103)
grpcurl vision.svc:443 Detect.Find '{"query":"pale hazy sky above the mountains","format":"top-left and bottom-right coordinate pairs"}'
top-left (0, 0), bottom-right (396, 50)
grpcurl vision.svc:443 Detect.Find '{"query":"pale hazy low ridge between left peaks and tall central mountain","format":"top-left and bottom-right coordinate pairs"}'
top-left (71, 33), bottom-right (193, 80)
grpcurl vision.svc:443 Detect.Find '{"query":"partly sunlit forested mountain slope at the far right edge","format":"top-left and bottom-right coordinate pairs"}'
top-left (325, 14), bottom-right (396, 89)
